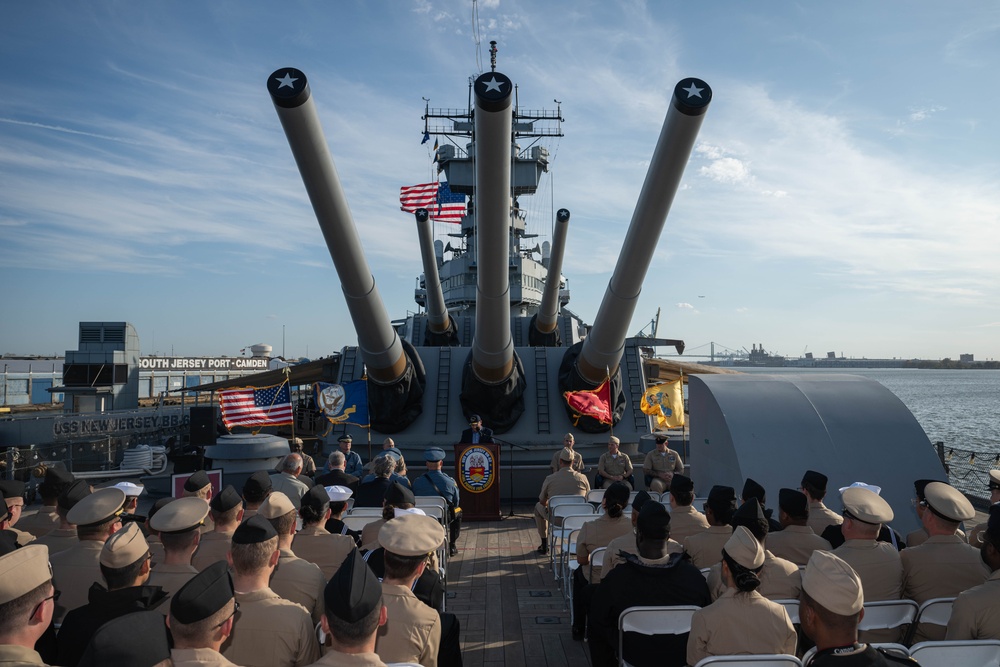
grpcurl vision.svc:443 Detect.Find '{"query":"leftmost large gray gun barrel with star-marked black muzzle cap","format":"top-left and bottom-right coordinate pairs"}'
top-left (267, 67), bottom-right (425, 433)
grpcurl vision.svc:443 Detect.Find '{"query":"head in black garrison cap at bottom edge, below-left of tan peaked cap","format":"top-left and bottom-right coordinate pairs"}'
top-left (309, 551), bottom-right (387, 667)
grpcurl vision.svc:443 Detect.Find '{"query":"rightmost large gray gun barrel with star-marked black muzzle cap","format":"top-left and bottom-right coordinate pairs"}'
top-left (559, 78), bottom-right (712, 431)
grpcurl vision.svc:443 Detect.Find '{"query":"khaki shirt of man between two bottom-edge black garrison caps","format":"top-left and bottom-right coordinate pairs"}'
top-left (222, 588), bottom-right (320, 667)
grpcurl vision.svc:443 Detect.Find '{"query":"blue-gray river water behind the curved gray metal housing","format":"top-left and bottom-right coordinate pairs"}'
top-left (733, 368), bottom-right (1000, 454)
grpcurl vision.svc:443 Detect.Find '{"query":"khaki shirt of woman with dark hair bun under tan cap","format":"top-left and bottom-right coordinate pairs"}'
top-left (687, 588), bottom-right (796, 665)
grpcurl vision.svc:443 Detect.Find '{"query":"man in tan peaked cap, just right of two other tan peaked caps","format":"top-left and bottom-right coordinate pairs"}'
top-left (149, 496), bottom-right (208, 600)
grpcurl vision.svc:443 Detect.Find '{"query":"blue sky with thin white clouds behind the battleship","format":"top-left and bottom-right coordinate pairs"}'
top-left (0, 0), bottom-right (1000, 360)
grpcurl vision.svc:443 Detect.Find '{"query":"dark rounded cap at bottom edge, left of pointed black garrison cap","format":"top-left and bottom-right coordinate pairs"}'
top-left (77, 611), bottom-right (170, 667)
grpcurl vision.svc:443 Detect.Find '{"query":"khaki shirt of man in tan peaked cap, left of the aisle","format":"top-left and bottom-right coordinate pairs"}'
top-left (375, 584), bottom-right (441, 667)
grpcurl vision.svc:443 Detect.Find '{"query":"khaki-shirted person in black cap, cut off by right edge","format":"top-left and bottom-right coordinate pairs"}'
top-left (945, 504), bottom-right (1000, 639)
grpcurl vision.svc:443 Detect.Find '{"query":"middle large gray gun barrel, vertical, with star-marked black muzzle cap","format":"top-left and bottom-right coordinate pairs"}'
top-left (461, 71), bottom-right (526, 433)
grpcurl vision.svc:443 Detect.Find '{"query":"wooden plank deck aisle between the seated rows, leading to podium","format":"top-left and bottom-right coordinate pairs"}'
top-left (447, 505), bottom-right (590, 667)
